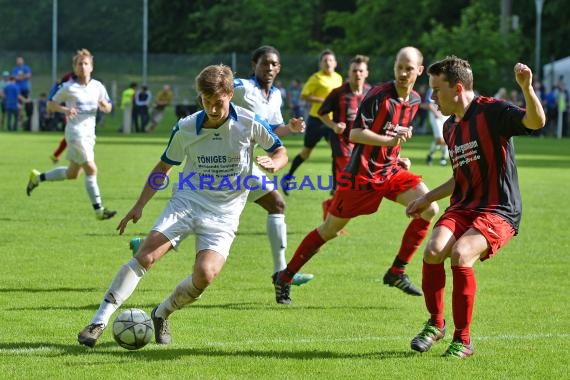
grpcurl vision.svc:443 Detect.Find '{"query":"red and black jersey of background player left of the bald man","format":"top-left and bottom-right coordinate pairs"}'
top-left (319, 82), bottom-right (371, 157)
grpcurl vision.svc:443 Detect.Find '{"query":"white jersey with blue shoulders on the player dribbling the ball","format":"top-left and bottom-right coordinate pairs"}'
top-left (161, 105), bottom-right (282, 217)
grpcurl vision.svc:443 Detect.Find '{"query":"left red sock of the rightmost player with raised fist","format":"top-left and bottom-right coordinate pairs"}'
top-left (422, 261), bottom-right (445, 328)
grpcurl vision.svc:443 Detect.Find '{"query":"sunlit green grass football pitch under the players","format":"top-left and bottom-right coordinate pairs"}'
top-left (0, 123), bottom-right (570, 379)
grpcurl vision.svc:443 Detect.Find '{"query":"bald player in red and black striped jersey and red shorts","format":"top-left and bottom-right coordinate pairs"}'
top-left (275, 47), bottom-right (438, 304)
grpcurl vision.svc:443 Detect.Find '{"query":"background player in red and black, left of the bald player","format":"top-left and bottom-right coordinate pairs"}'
top-left (319, 55), bottom-right (371, 220)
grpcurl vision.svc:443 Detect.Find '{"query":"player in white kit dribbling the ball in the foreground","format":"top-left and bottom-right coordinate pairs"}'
top-left (78, 65), bottom-right (287, 347)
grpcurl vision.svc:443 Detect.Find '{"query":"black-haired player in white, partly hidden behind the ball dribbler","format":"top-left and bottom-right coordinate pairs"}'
top-left (232, 46), bottom-right (313, 292)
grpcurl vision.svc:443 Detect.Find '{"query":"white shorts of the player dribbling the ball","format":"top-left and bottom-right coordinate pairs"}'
top-left (152, 194), bottom-right (239, 259)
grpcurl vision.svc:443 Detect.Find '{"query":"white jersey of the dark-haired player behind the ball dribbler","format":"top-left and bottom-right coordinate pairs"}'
top-left (232, 76), bottom-right (285, 130)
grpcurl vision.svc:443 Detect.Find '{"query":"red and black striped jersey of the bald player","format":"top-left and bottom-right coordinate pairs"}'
top-left (346, 82), bottom-right (421, 182)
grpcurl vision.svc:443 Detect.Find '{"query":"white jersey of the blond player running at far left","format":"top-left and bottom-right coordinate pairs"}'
top-left (51, 79), bottom-right (111, 140)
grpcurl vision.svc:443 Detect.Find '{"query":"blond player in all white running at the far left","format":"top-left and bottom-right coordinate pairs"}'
top-left (26, 49), bottom-right (117, 220)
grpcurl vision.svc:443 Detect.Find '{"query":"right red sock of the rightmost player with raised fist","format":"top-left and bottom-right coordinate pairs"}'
top-left (451, 266), bottom-right (477, 344)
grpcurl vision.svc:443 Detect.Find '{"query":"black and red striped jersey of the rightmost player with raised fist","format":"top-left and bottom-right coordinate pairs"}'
top-left (443, 96), bottom-right (532, 231)
